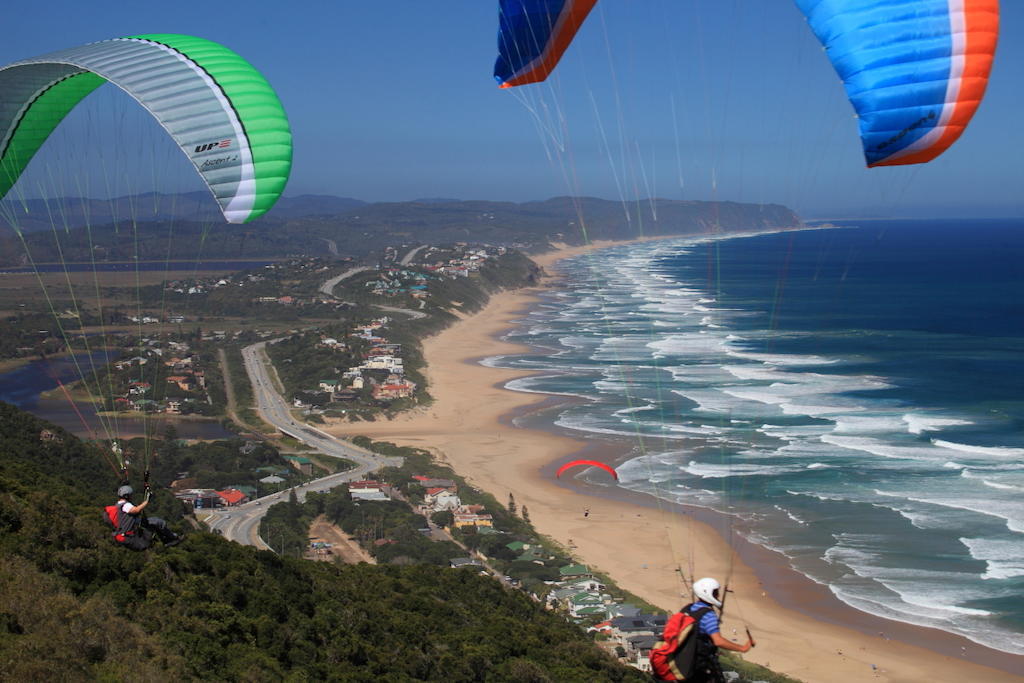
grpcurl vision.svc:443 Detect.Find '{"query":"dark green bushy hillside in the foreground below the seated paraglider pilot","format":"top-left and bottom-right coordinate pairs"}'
top-left (0, 404), bottom-right (646, 682)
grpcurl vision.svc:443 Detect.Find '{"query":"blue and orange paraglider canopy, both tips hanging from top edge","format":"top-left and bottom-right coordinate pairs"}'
top-left (495, 0), bottom-right (999, 167)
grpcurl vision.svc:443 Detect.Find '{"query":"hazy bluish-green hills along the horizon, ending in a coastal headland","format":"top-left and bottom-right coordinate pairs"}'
top-left (0, 193), bottom-right (801, 265)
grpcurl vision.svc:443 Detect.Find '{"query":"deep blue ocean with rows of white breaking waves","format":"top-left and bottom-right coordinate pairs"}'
top-left (485, 220), bottom-right (1024, 654)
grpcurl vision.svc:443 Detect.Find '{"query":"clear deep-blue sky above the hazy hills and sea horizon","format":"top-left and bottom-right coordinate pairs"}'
top-left (0, 0), bottom-right (1024, 217)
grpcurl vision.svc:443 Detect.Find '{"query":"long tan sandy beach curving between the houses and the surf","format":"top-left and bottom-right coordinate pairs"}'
top-left (329, 243), bottom-right (1024, 681)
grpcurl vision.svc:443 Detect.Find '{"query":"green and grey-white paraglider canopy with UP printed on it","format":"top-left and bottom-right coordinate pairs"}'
top-left (0, 34), bottom-right (292, 223)
